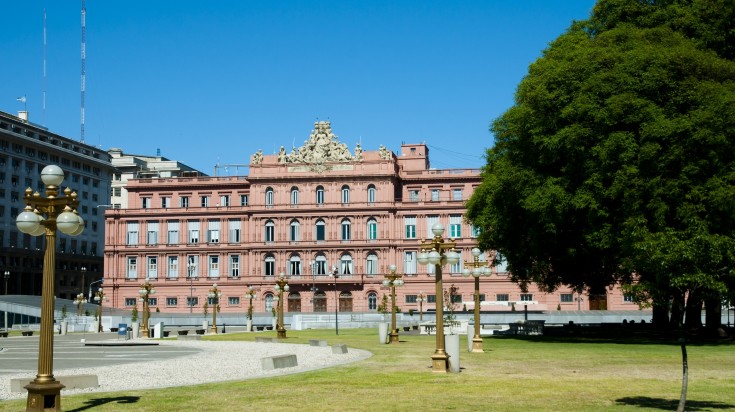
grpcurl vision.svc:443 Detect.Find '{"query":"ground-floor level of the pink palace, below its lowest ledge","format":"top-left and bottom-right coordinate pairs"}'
top-left (104, 274), bottom-right (638, 314)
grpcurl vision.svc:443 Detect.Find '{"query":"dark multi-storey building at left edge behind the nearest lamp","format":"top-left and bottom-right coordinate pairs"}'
top-left (0, 112), bottom-right (113, 299)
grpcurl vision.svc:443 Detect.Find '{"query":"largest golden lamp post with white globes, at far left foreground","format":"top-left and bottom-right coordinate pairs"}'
top-left (16, 165), bottom-right (84, 411)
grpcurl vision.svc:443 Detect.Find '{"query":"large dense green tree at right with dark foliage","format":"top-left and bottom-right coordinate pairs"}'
top-left (467, 0), bottom-right (735, 409)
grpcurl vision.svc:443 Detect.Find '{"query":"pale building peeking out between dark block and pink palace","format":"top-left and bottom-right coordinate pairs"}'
top-left (108, 148), bottom-right (206, 209)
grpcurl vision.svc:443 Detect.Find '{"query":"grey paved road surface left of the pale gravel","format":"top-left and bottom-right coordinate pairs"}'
top-left (0, 332), bottom-right (200, 376)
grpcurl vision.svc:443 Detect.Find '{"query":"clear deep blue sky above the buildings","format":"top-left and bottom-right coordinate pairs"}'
top-left (0, 0), bottom-right (594, 175)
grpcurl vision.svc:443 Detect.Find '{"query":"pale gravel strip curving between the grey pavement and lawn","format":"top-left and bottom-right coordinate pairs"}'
top-left (0, 340), bottom-right (372, 399)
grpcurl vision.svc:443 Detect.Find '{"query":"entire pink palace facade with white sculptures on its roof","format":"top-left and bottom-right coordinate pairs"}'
top-left (104, 122), bottom-right (637, 314)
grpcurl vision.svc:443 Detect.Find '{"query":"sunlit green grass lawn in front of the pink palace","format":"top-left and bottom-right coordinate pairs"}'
top-left (0, 329), bottom-right (735, 412)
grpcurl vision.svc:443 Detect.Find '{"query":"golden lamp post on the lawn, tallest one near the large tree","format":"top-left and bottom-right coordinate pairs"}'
top-left (417, 222), bottom-right (459, 373)
